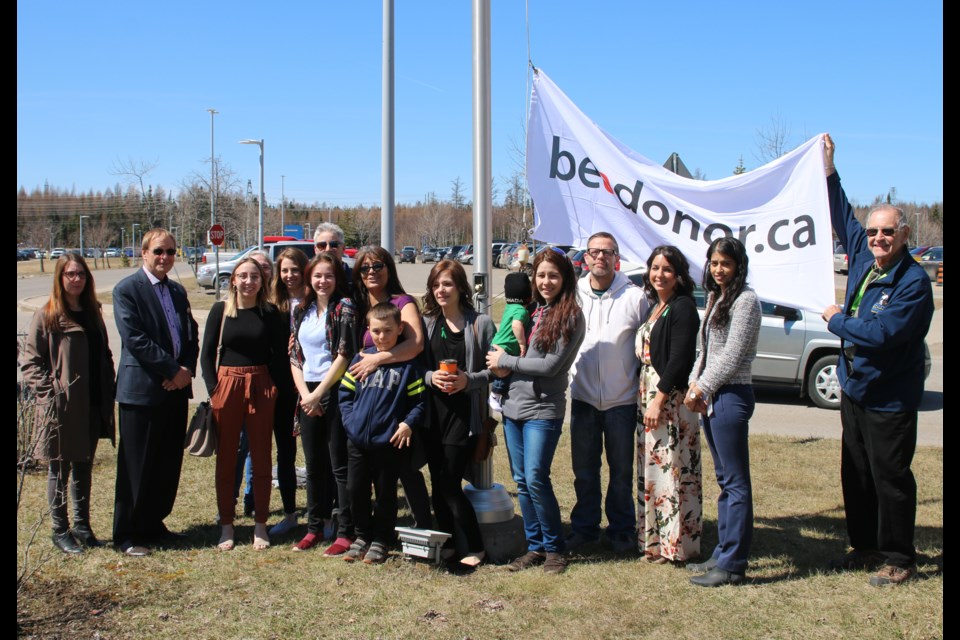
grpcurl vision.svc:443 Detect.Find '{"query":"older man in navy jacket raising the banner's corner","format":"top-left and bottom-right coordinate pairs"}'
top-left (823, 135), bottom-right (933, 586)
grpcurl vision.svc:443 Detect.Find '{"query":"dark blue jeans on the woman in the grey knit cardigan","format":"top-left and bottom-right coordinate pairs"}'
top-left (703, 384), bottom-right (755, 573)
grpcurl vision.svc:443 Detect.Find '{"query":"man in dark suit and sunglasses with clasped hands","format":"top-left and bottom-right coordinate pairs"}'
top-left (113, 229), bottom-right (199, 556)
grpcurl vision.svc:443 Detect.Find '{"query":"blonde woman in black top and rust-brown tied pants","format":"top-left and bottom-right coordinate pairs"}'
top-left (200, 258), bottom-right (290, 551)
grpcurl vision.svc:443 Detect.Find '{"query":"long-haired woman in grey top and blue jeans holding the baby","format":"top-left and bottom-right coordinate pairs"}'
top-left (487, 249), bottom-right (585, 573)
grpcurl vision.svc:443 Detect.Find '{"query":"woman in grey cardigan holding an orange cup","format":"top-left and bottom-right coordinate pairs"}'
top-left (423, 260), bottom-right (495, 567)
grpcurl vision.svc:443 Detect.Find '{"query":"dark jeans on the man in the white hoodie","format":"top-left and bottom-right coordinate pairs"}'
top-left (570, 400), bottom-right (637, 540)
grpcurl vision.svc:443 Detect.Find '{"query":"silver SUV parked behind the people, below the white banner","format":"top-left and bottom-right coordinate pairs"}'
top-left (624, 269), bottom-right (840, 409)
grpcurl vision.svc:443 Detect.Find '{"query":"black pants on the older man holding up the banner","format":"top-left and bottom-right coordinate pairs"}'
top-left (840, 396), bottom-right (917, 567)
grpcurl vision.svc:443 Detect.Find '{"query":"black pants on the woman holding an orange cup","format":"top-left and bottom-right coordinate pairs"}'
top-left (427, 436), bottom-right (483, 551)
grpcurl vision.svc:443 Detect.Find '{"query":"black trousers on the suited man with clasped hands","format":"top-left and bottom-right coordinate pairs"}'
top-left (113, 400), bottom-right (187, 544)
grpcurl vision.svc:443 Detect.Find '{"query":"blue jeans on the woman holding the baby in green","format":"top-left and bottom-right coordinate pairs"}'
top-left (503, 417), bottom-right (566, 553)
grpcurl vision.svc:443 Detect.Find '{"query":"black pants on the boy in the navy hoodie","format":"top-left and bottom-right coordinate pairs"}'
top-left (347, 441), bottom-right (409, 546)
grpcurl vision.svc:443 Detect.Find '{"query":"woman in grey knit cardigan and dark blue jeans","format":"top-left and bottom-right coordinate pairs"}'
top-left (684, 237), bottom-right (761, 587)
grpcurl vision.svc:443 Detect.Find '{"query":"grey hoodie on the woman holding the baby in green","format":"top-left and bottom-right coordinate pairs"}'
top-left (497, 307), bottom-right (586, 422)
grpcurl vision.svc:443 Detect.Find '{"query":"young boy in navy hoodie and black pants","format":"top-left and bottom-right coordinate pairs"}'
top-left (340, 302), bottom-right (425, 564)
